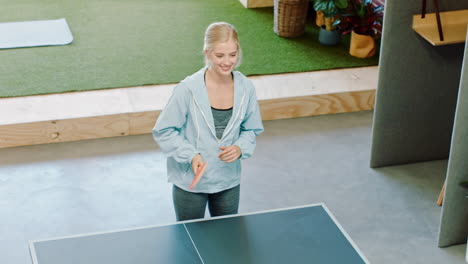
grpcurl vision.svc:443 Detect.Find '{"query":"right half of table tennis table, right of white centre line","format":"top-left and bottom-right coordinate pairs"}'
top-left (186, 206), bottom-right (366, 264)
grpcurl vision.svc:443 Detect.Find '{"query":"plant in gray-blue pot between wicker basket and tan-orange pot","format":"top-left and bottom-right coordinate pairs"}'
top-left (314, 0), bottom-right (348, 45)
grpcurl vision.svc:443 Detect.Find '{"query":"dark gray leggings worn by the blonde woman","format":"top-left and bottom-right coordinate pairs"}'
top-left (172, 185), bottom-right (240, 221)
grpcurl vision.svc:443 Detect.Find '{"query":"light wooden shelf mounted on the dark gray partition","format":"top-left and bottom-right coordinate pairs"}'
top-left (413, 9), bottom-right (468, 46)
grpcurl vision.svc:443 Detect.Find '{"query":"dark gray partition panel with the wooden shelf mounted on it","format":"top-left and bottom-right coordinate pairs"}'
top-left (371, 0), bottom-right (468, 167)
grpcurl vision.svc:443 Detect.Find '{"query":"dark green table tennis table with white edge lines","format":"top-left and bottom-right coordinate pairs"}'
top-left (29, 203), bottom-right (369, 264)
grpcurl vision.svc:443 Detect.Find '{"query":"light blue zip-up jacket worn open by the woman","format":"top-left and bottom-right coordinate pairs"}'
top-left (153, 68), bottom-right (263, 193)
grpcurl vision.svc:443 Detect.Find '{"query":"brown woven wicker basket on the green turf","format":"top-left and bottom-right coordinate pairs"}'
top-left (273, 0), bottom-right (309, 38)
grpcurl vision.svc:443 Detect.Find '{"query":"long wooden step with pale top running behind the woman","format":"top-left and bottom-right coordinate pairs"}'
top-left (0, 66), bottom-right (377, 148)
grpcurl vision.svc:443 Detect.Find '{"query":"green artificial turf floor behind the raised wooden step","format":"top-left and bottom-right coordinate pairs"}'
top-left (0, 0), bottom-right (378, 97)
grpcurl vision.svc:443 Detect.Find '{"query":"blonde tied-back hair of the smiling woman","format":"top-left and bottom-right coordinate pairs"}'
top-left (203, 22), bottom-right (242, 68)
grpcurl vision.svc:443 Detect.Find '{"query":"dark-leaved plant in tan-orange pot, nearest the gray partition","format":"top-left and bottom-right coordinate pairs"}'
top-left (335, 0), bottom-right (383, 58)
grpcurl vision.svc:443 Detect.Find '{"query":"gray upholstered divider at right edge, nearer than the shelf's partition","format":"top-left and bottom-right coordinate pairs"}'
top-left (439, 31), bottom-right (468, 247)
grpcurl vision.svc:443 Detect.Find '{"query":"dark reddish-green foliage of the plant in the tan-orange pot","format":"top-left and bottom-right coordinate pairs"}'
top-left (333, 0), bottom-right (384, 38)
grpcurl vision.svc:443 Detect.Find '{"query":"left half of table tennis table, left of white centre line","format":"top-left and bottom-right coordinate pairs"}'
top-left (31, 224), bottom-right (202, 264)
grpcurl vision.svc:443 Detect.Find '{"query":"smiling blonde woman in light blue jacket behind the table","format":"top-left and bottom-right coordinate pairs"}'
top-left (153, 22), bottom-right (263, 221)
